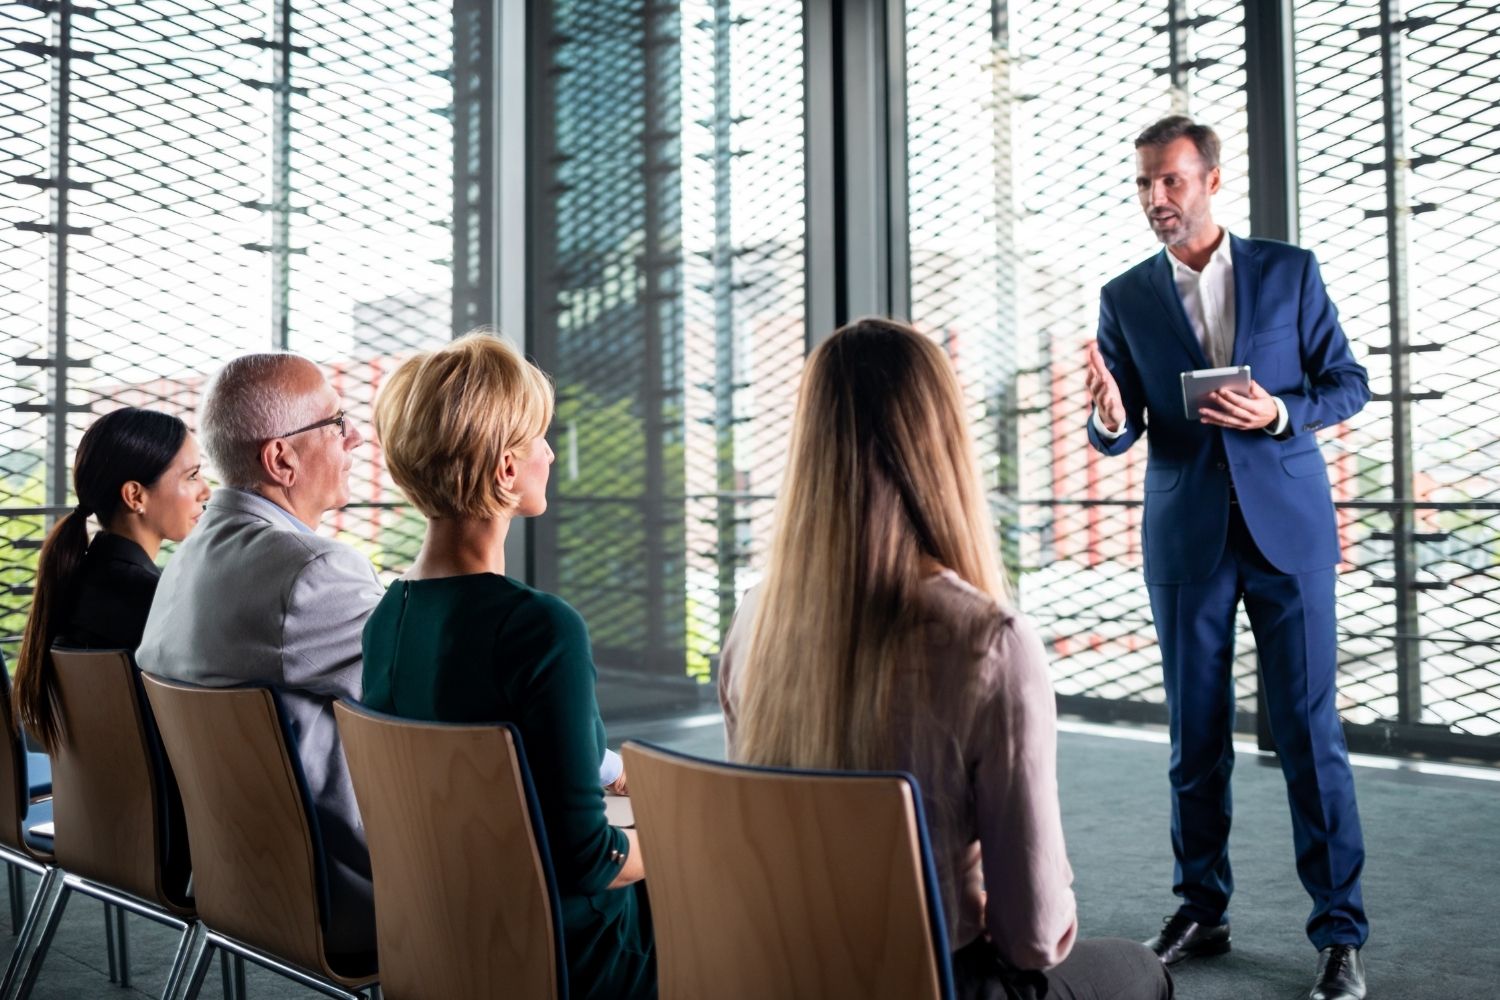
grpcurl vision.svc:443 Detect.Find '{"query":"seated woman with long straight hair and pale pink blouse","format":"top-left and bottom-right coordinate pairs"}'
top-left (719, 319), bottom-right (1172, 1000)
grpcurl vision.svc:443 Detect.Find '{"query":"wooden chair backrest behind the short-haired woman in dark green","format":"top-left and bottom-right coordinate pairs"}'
top-left (333, 702), bottom-right (567, 1000)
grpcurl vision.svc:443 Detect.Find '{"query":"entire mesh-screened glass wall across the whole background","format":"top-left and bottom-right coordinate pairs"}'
top-left (0, 0), bottom-right (1500, 757)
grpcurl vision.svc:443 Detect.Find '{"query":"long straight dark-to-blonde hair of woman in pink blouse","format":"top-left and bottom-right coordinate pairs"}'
top-left (735, 319), bottom-right (1008, 769)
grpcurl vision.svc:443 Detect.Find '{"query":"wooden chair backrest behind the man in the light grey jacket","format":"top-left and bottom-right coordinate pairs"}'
top-left (141, 673), bottom-right (341, 979)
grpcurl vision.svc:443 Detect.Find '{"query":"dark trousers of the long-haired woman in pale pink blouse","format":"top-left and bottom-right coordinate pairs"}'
top-left (953, 937), bottom-right (1172, 1000)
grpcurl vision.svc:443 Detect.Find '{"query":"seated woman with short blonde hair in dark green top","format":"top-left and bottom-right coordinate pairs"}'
top-left (365, 334), bottom-right (656, 1000)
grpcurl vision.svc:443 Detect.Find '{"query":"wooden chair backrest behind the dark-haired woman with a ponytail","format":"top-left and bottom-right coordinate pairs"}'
top-left (51, 648), bottom-right (192, 916)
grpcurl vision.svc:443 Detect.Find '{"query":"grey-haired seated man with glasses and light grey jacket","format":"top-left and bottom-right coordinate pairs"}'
top-left (137, 354), bottom-right (383, 952)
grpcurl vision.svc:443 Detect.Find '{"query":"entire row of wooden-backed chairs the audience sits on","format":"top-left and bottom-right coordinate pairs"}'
top-left (0, 651), bottom-right (953, 1000)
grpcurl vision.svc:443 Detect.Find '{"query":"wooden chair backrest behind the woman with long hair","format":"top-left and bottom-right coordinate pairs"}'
top-left (621, 742), bottom-right (953, 1000)
